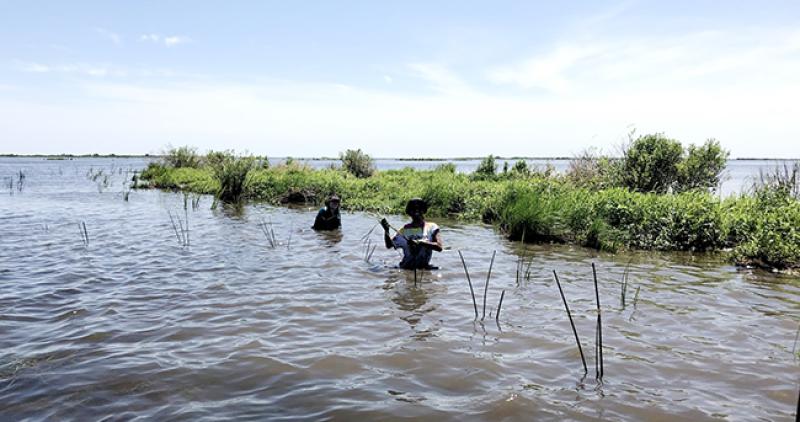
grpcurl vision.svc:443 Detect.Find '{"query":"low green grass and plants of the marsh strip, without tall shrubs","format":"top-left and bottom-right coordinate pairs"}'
top-left (142, 160), bottom-right (800, 269)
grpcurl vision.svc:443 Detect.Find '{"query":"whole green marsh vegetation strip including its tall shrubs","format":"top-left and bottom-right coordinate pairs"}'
top-left (140, 135), bottom-right (800, 270)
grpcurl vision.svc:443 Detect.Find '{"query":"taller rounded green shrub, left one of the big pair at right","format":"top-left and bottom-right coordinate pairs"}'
top-left (622, 134), bottom-right (683, 193)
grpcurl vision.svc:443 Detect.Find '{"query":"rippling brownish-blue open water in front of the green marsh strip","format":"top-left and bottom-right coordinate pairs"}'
top-left (0, 159), bottom-right (800, 420)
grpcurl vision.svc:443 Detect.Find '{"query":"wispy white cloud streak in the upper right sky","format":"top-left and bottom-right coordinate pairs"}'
top-left (486, 28), bottom-right (800, 96)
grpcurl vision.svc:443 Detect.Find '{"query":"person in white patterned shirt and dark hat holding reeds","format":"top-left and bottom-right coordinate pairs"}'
top-left (381, 198), bottom-right (443, 270)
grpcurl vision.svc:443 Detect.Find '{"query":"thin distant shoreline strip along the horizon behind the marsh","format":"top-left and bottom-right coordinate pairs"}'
top-left (0, 154), bottom-right (800, 162)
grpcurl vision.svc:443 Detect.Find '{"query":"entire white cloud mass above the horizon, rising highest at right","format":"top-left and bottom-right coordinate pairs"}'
top-left (0, 29), bottom-right (800, 157)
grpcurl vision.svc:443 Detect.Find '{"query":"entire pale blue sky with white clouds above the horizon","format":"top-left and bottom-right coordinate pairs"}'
top-left (0, 0), bottom-right (800, 158)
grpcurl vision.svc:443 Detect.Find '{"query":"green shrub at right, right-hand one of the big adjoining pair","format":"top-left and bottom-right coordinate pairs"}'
top-left (675, 139), bottom-right (730, 192)
